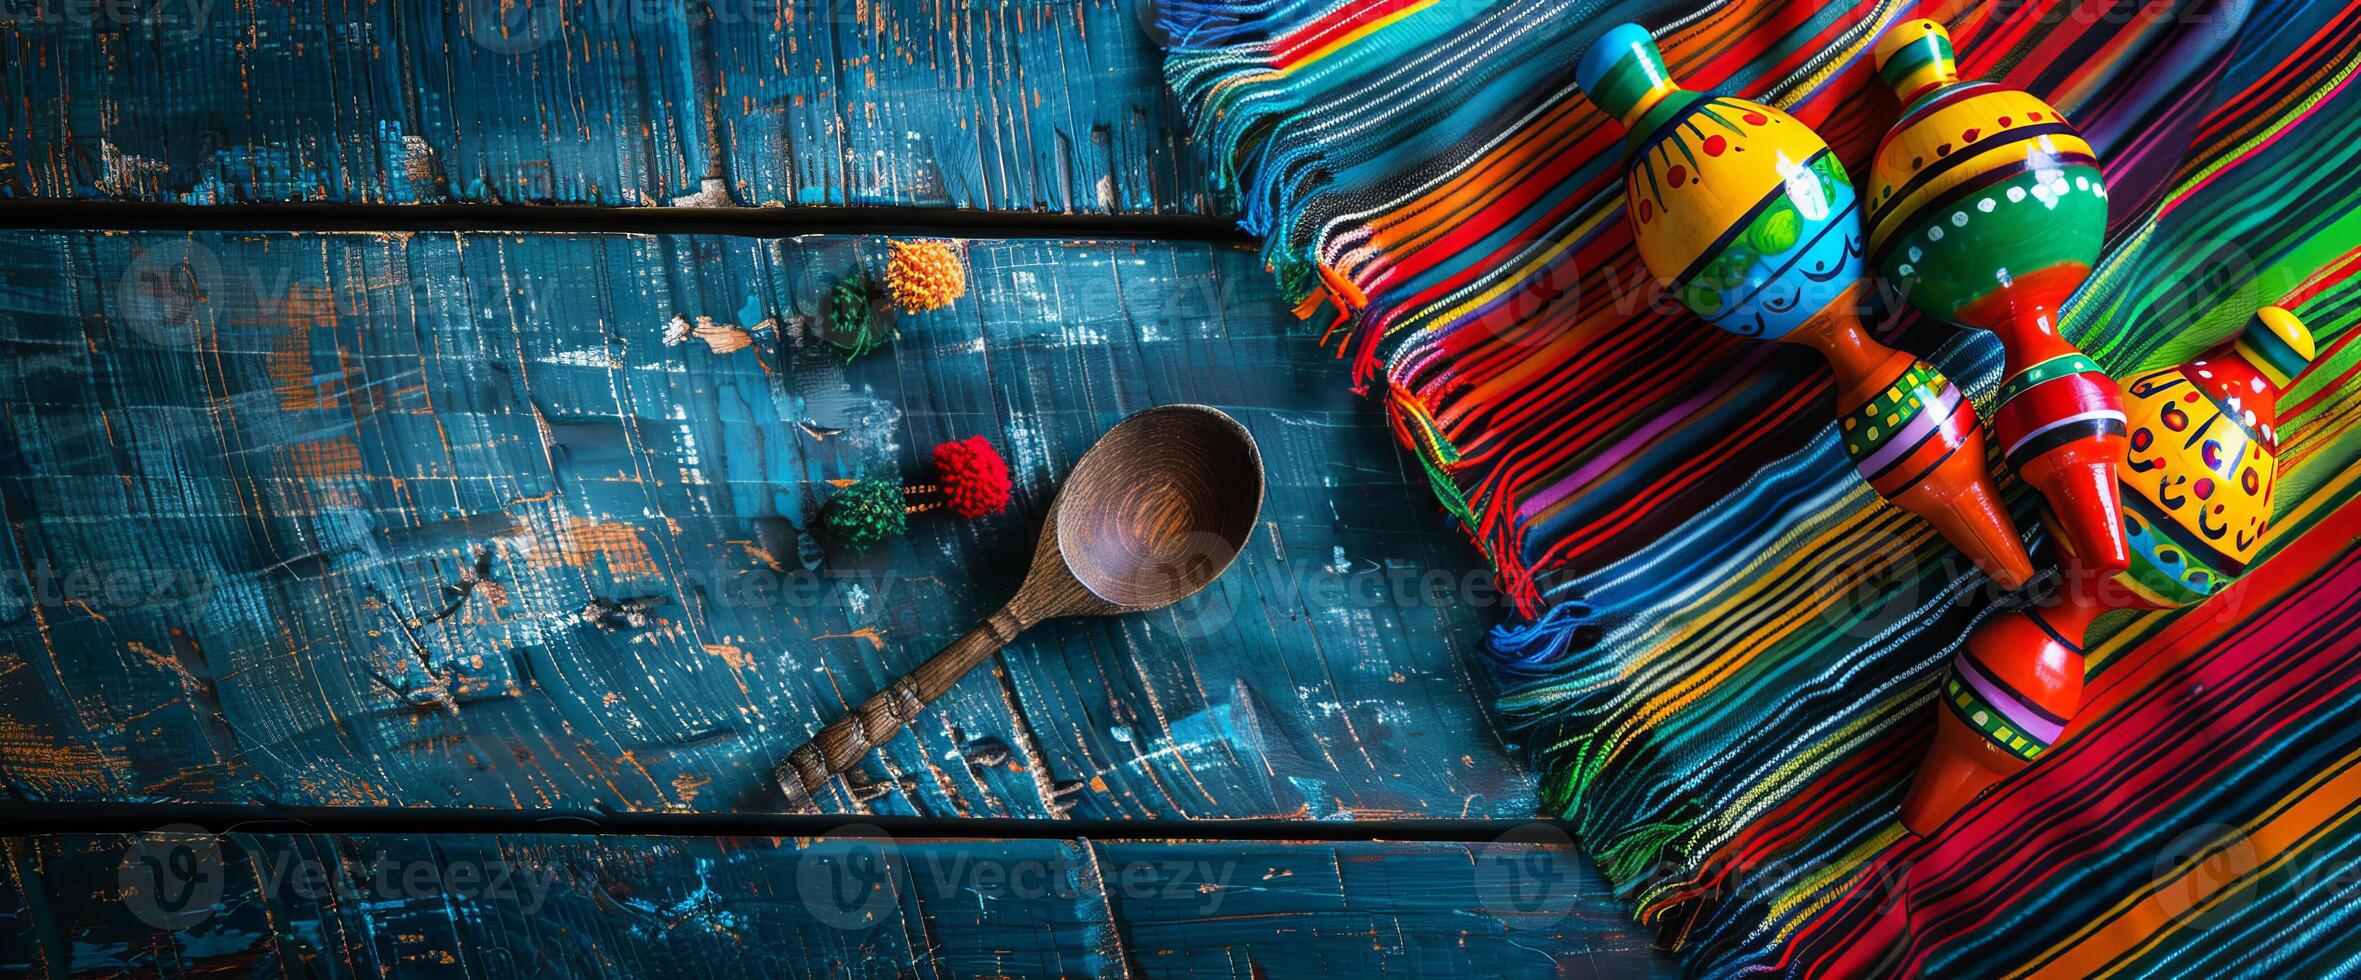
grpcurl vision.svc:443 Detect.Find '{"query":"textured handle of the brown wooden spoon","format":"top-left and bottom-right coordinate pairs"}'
top-left (772, 609), bottom-right (1027, 810)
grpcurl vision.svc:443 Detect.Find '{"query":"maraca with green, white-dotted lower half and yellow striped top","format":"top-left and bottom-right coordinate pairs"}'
top-left (1868, 21), bottom-right (2130, 574)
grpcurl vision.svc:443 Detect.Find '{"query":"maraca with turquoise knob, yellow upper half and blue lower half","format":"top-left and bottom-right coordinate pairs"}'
top-left (1575, 24), bottom-right (2033, 588)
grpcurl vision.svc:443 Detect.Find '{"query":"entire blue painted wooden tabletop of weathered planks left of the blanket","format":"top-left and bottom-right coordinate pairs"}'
top-left (0, 0), bottom-right (1662, 978)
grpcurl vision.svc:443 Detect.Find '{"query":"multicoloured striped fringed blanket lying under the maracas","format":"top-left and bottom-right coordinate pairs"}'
top-left (1157, 0), bottom-right (2361, 975)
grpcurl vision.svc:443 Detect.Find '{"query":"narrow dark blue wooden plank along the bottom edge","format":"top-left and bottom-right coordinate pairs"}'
top-left (0, 834), bottom-right (1669, 978)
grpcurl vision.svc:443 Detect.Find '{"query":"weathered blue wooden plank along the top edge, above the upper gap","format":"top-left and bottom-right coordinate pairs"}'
top-left (0, 0), bottom-right (1214, 213)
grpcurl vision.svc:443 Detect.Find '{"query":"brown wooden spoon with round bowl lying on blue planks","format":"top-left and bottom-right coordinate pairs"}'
top-left (777, 404), bottom-right (1263, 810)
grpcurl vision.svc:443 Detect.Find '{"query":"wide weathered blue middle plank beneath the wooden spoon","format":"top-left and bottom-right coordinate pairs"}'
top-left (0, 231), bottom-right (1535, 819)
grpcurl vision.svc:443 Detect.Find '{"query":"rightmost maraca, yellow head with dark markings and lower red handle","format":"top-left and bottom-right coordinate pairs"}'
top-left (1901, 307), bottom-right (2311, 834)
